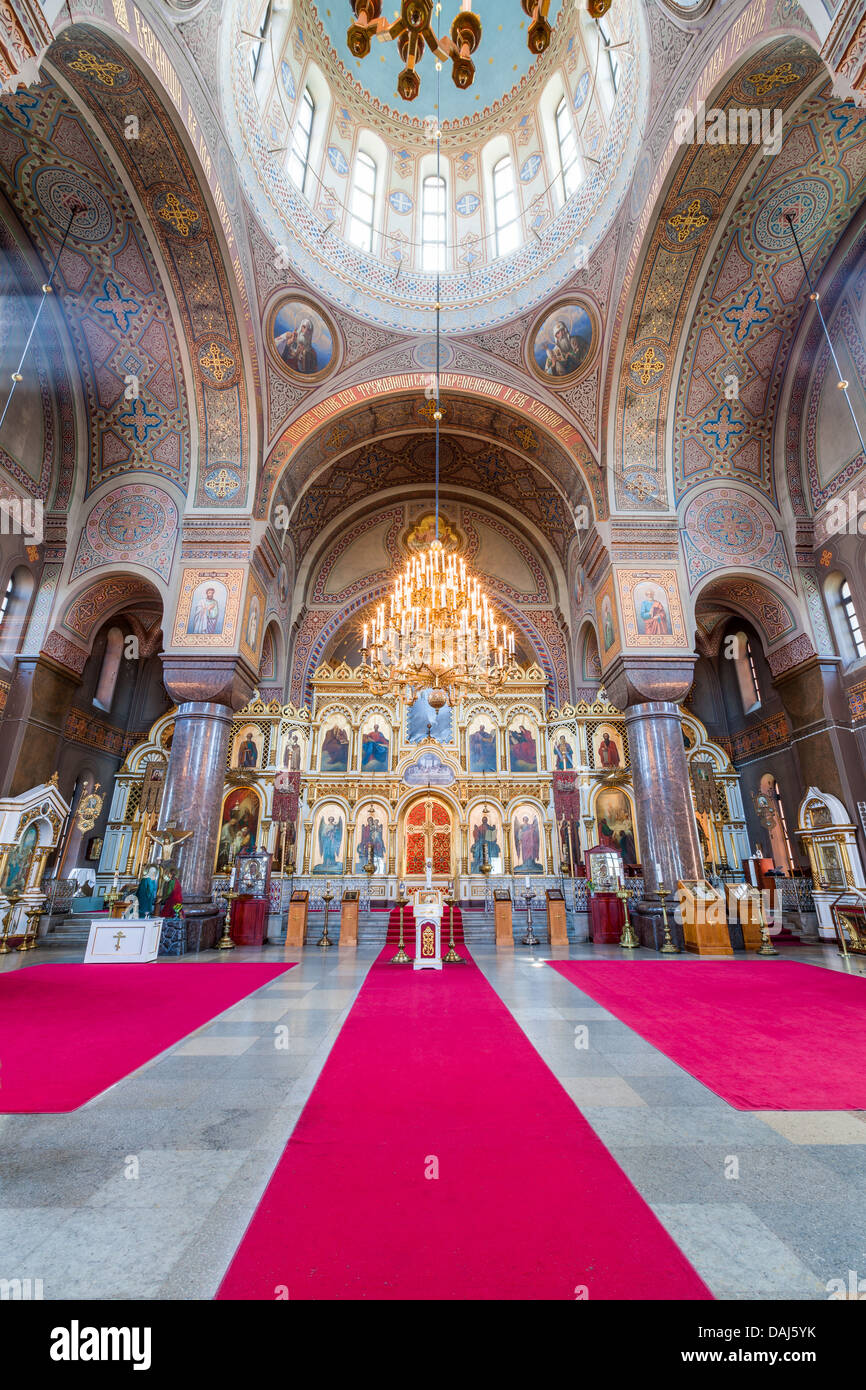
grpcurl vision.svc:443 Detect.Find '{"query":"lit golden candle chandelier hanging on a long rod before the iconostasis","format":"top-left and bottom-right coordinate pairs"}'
top-left (360, 63), bottom-right (514, 709)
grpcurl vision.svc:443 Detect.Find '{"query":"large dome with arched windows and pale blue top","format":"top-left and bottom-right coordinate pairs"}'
top-left (221, 0), bottom-right (646, 332)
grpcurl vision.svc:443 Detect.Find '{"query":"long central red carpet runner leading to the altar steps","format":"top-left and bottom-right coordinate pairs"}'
top-left (217, 948), bottom-right (712, 1302)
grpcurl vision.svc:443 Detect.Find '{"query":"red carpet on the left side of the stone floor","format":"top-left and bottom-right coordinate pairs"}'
top-left (0, 960), bottom-right (292, 1115)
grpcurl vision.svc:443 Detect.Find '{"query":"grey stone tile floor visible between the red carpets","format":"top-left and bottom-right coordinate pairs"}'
top-left (0, 947), bottom-right (866, 1300)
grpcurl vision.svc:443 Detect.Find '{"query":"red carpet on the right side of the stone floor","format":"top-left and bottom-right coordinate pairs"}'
top-left (548, 960), bottom-right (866, 1111)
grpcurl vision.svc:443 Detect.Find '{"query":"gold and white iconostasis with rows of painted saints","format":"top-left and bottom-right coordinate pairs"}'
top-left (100, 664), bottom-right (748, 898)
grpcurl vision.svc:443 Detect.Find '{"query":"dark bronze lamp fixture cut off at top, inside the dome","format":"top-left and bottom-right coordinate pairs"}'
top-left (346, 0), bottom-right (481, 101)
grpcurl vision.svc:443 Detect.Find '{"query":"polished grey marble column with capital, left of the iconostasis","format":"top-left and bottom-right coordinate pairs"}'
top-left (158, 656), bottom-right (253, 945)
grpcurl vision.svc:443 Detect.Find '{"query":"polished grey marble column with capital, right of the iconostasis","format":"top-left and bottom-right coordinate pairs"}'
top-left (605, 656), bottom-right (703, 949)
